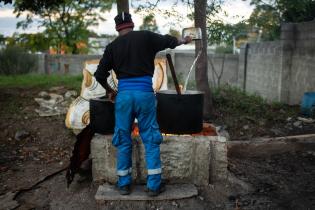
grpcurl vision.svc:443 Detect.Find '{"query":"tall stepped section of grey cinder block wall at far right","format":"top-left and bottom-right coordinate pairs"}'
top-left (238, 21), bottom-right (315, 104)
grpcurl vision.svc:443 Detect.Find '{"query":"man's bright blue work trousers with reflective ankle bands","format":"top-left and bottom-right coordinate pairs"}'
top-left (112, 90), bottom-right (163, 190)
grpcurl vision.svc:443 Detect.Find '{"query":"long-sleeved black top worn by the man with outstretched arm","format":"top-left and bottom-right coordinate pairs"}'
top-left (94, 31), bottom-right (178, 87)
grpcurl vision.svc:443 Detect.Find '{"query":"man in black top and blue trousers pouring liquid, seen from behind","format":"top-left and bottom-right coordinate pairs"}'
top-left (94, 12), bottom-right (191, 196)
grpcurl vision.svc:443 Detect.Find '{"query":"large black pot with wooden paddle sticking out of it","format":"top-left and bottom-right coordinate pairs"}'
top-left (156, 90), bottom-right (204, 134)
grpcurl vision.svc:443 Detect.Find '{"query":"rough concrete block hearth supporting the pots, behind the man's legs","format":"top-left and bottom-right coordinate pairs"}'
top-left (91, 135), bottom-right (227, 185)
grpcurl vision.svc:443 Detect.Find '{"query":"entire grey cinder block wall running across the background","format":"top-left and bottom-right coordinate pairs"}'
top-left (37, 21), bottom-right (315, 104)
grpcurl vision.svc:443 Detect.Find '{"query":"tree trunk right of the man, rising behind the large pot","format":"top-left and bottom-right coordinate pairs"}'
top-left (194, 0), bottom-right (213, 120)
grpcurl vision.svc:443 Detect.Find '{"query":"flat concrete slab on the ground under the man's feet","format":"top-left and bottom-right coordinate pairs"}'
top-left (95, 184), bottom-right (198, 202)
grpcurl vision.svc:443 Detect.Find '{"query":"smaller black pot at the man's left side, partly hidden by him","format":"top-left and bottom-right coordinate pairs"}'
top-left (90, 98), bottom-right (115, 134)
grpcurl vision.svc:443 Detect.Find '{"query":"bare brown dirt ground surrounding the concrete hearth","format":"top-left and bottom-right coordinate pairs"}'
top-left (0, 88), bottom-right (315, 210)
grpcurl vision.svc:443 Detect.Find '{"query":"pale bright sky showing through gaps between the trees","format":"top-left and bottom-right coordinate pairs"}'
top-left (0, 0), bottom-right (253, 36)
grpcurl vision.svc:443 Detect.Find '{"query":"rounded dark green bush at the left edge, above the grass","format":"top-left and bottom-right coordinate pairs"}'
top-left (0, 46), bottom-right (36, 75)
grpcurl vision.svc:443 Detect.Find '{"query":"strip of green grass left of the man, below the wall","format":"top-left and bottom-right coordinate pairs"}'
top-left (0, 74), bottom-right (83, 90)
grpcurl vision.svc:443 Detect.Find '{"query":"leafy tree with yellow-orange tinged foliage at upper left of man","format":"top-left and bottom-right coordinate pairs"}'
top-left (14, 0), bottom-right (113, 54)
